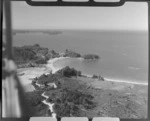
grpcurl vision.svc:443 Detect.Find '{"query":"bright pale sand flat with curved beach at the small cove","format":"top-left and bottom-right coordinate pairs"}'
top-left (17, 57), bottom-right (68, 92)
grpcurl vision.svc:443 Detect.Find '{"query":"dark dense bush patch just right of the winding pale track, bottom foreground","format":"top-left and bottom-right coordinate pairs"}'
top-left (54, 89), bottom-right (96, 117)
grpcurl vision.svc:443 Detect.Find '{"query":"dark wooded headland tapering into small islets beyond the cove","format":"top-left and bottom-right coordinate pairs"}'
top-left (13, 44), bottom-right (99, 68)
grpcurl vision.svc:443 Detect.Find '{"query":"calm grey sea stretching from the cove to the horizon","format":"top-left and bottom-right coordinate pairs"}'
top-left (13, 31), bottom-right (148, 83)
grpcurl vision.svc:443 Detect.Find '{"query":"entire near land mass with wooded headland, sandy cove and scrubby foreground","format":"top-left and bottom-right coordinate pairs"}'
top-left (14, 44), bottom-right (148, 119)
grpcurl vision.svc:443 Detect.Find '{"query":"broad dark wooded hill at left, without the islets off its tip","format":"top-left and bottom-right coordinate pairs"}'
top-left (13, 44), bottom-right (59, 67)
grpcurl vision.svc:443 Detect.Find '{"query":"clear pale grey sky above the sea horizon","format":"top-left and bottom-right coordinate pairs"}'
top-left (2, 1), bottom-right (148, 31)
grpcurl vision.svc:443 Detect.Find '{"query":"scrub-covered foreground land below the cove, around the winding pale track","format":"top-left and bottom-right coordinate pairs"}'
top-left (26, 67), bottom-right (147, 119)
